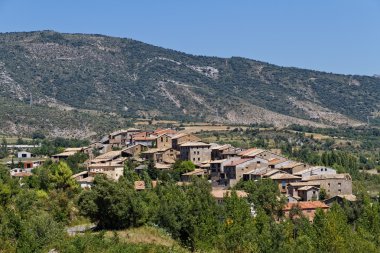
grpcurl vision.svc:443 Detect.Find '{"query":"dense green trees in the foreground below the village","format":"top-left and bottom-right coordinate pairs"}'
top-left (0, 157), bottom-right (380, 252)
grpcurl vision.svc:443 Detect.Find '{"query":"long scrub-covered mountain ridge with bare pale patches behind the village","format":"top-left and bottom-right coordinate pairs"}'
top-left (0, 31), bottom-right (380, 136)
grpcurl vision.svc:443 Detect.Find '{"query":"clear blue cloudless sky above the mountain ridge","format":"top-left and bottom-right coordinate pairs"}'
top-left (0, 0), bottom-right (380, 75)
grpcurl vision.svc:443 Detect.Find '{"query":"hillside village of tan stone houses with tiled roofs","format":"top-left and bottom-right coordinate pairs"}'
top-left (3, 128), bottom-right (356, 221)
